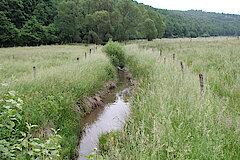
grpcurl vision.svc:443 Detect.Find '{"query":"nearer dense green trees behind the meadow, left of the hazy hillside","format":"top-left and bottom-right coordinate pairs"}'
top-left (0, 0), bottom-right (165, 46)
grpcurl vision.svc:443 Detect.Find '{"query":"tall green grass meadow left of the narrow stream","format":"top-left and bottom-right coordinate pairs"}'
top-left (0, 45), bottom-right (115, 159)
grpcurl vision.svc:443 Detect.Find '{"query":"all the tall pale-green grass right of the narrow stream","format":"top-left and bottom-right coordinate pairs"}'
top-left (100, 37), bottom-right (240, 160)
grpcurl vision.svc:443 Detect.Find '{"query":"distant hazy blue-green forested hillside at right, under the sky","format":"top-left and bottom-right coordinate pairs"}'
top-left (158, 9), bottom-right (240, 37)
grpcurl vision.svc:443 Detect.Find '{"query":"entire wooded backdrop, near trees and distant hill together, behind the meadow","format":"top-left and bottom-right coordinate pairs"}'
top-left (0, 0), bottom-right (240, 47)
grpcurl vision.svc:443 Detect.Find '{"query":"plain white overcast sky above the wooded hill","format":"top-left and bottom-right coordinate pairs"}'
top-left (136, 0), bottom-right (240, 14)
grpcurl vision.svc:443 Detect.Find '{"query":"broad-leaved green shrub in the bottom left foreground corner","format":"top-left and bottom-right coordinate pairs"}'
top-left (0, 88), bottom-right (61, 160)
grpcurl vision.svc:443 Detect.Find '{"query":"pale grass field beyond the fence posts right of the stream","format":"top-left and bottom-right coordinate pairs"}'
top-left (140, 37), bottom-right (240, 112)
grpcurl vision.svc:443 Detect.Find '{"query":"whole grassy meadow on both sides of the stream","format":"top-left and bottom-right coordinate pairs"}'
top-left (0, 37), bottom-right (240, 160)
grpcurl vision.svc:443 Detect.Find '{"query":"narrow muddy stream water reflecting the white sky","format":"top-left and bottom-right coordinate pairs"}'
top-left (78, 73), bottom-right (130, 160)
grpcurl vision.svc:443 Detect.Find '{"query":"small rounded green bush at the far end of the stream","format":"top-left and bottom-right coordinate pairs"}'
top-left (103, 41), bottom-right (125, 68)
